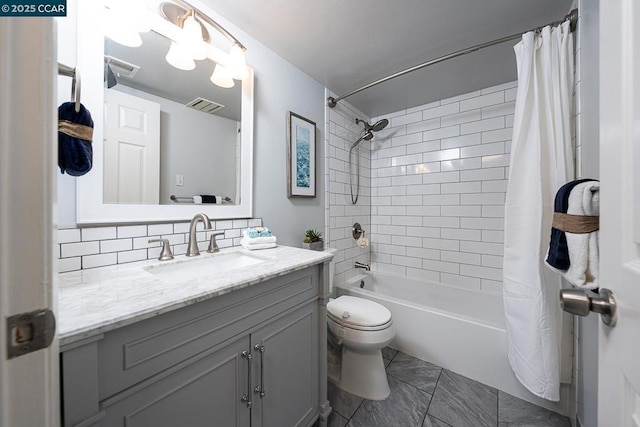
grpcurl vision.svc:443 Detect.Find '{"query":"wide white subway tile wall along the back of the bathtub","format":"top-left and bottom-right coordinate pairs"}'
top-left (370, 82), bottom-right (517, 292)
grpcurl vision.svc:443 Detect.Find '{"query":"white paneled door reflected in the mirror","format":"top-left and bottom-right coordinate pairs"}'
top-left (104, 89), bottom-right (160, 204)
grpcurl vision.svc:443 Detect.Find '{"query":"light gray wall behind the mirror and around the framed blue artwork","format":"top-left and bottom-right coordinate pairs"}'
top-left (57, 2), bottom-right (325, 246)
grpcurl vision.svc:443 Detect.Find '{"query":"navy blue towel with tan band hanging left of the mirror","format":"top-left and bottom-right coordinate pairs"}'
top-left (58, 102), bottom-right (93, 176)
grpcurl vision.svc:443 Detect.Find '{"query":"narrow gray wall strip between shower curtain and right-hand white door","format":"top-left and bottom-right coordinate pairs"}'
top-left (576, 0), bottom-right (600, 427)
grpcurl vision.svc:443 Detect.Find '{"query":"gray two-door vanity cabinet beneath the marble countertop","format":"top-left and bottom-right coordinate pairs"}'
top-left (61, 265), bottom-right (328, 427)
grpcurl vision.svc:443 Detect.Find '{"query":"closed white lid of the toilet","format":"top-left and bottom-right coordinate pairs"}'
top-left (327, 295), bottom-right (391, 326)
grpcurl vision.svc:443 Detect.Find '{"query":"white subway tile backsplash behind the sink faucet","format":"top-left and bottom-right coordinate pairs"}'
top-left (58, 218), bottom-right (262, 273)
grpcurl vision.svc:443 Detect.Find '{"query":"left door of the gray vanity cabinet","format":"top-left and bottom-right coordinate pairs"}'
top-left (100, 335), bottom-right (251, 427)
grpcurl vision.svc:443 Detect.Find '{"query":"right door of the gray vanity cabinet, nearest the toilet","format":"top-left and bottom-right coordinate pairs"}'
top-left (251, 301), bottom-right (319, 427)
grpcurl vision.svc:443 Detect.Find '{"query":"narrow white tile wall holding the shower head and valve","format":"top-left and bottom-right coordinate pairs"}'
top-left (325, 91), bottom-right (370, 283)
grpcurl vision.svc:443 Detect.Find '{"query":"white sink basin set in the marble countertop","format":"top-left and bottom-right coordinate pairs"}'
top-left (145, 252), bottom-right (268, 281)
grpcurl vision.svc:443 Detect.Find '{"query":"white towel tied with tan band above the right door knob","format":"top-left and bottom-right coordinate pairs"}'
top-left (547, 181), bottom-right (600, 289)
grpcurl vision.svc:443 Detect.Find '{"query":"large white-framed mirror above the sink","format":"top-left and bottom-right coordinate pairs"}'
top-left (76, 2), bottom-right (254, 225)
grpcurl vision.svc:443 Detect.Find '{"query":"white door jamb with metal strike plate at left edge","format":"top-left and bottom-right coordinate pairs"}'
top-left (0, 18), bottom-right (59, 427)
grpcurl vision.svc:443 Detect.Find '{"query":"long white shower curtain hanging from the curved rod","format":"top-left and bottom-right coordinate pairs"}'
top-left (503, 22), bottom-right (574, 401)
